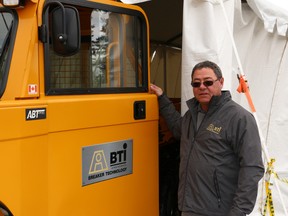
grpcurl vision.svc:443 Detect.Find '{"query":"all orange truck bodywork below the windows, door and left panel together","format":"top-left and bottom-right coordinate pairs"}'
top-left (0, 93), bottom-right (159, 216)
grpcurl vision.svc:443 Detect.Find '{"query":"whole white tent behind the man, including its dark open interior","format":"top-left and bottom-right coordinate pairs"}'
top-left (129, 0), bottom-right (288, 216)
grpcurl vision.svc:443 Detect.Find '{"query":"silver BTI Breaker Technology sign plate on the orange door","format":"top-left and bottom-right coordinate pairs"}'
top-left (82, 139), bottom-right (133, 186)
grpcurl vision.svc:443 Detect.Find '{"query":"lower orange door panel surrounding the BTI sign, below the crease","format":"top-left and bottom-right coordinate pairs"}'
top-left (45, 122), bottom-right (158, 216)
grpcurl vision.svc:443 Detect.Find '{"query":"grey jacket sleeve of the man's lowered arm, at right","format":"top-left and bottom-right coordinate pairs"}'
top-left (228, 113), bottom-right (264, 216)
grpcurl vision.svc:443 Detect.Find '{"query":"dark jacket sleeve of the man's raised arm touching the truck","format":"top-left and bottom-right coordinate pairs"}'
top-left (158, 94), bottom-right (182, 139)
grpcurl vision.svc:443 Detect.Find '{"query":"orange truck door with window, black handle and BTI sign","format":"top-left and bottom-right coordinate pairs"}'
top-left (40, 1), bottom-right (159, 216)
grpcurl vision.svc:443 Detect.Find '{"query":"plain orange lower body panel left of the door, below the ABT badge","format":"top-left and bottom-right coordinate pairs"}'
top-left (0, 136), bottom-right (48, 216)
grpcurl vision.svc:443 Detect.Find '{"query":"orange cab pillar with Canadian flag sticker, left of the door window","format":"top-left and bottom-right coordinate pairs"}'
top-left (1, 1), bottom-right (40, 100)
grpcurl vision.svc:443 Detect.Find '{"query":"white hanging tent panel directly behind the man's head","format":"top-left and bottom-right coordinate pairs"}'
top-left (181, 0), bottom-right (234, 113)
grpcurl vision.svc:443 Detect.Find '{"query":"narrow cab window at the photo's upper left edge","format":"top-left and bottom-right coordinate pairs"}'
top-left (0, 8), bottom-right (14, 96)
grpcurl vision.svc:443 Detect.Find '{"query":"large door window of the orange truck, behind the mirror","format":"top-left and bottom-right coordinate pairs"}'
top-left (45, 4), bottom-right (148, 95)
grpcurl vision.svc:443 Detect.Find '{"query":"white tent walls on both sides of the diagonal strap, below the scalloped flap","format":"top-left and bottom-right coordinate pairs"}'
top-left (181, 0), bottom-right (288, 215)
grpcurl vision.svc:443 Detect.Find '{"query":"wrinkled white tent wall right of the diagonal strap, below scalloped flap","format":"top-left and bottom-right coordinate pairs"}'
top-left (232, 2), bottom-right (288, 215)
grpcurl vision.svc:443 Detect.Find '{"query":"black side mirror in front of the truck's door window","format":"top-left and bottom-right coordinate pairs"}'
top-left (51, 6), bottom-right (81, 56)
